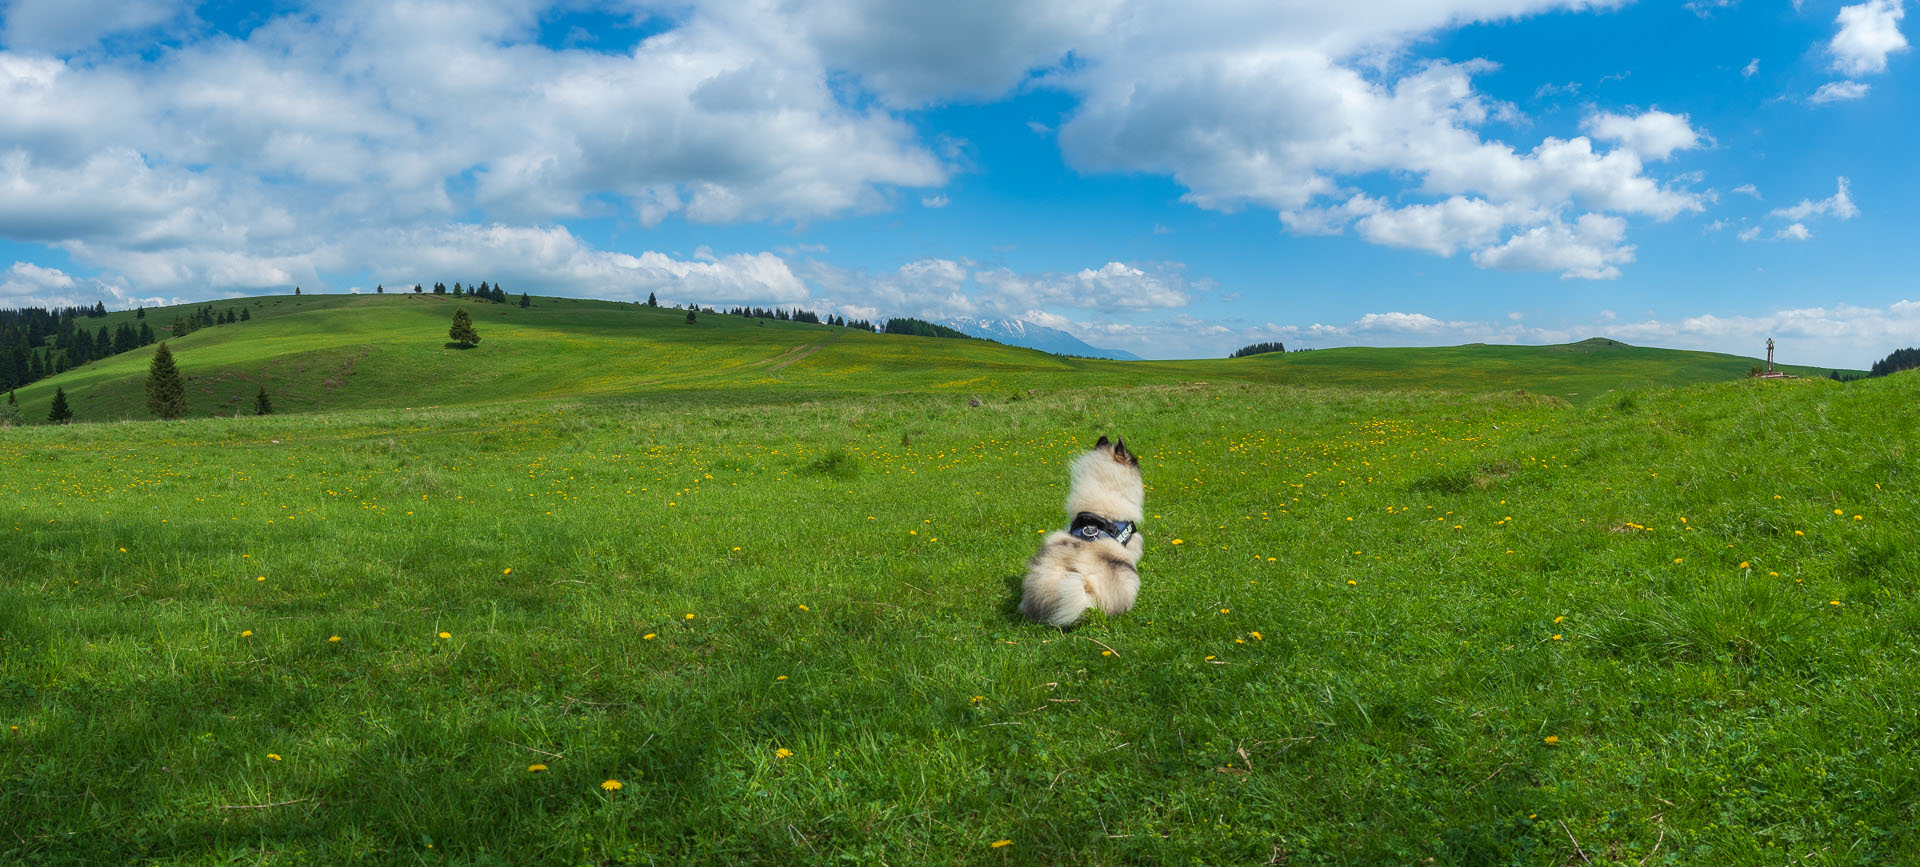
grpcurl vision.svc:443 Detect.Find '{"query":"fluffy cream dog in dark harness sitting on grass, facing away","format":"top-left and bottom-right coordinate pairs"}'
top-left (1020, 437), bottom-right (1146, 625)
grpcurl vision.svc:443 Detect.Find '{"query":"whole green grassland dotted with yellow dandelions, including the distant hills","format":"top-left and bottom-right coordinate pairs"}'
top-left (0, 295), bottom-right (1920, 865)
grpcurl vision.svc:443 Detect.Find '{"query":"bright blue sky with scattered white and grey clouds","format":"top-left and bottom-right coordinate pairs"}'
top-left (0, 0), bottom-right (1920, 368)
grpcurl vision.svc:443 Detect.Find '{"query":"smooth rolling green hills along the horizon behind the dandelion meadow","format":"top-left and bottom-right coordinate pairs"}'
top-left (0, 293), bottom-right (1858, 422)
